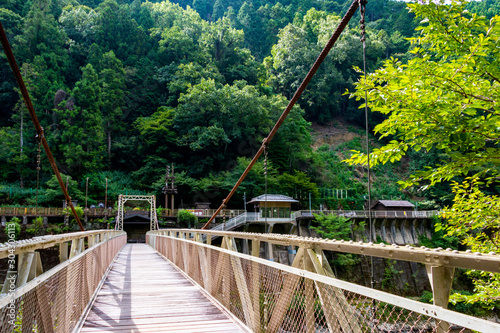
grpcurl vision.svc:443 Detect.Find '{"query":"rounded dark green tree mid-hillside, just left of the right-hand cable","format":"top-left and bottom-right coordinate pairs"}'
top-left (174, 79), bottom-right (272, 175)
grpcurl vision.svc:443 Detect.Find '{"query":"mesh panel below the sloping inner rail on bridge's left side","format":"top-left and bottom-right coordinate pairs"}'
top-left (0, 233), bottom-right (127, 333)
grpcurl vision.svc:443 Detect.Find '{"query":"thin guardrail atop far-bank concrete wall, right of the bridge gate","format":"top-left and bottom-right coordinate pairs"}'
top-left (292, 210), bottom-right (439, 219)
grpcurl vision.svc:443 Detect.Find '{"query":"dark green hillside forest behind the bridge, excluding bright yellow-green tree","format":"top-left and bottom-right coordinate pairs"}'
top-left (0, 0), bottom-right (426, 208)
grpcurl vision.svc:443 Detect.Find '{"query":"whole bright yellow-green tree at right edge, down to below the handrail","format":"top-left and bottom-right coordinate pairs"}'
top-left (347, 1), bottom-right (500, 302)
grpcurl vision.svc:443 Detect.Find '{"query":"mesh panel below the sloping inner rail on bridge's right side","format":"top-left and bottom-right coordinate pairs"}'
top-left (148, 234), bottom-right (500, 333)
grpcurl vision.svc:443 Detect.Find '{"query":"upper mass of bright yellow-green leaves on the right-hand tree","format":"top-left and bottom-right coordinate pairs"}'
top-left (349, 3), bottom-right (500, 185)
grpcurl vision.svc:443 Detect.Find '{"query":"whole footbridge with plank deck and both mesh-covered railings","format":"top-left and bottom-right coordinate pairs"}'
top-left (0, 224), bottom-right (500, 332)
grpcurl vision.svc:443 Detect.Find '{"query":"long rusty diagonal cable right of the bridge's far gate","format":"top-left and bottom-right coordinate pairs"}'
top-left (202, 0), bottom-right (359, 229)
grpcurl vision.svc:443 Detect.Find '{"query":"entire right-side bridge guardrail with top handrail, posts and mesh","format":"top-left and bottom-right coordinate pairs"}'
top-left (147, 229), bottom-right (500, 333)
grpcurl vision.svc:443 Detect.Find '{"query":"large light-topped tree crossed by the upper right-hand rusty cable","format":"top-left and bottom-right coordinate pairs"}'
top-left (264, 9), bottom-right (385, 123)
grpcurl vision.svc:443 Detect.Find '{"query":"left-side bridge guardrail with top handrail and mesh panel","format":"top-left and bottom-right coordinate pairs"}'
top-left (0, 230), bottom-right (127, 333)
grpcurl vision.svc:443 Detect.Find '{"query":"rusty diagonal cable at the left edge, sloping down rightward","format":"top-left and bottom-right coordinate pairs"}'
top-left (0, 22), bottom-right (85, 231)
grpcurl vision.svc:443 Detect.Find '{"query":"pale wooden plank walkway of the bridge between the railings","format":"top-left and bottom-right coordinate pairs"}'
top-left (80, 244), bottom-right (246, 332)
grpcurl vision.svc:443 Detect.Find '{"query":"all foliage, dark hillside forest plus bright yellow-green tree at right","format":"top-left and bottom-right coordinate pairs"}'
top-left (0, 0), bottom-right (500, 308)
